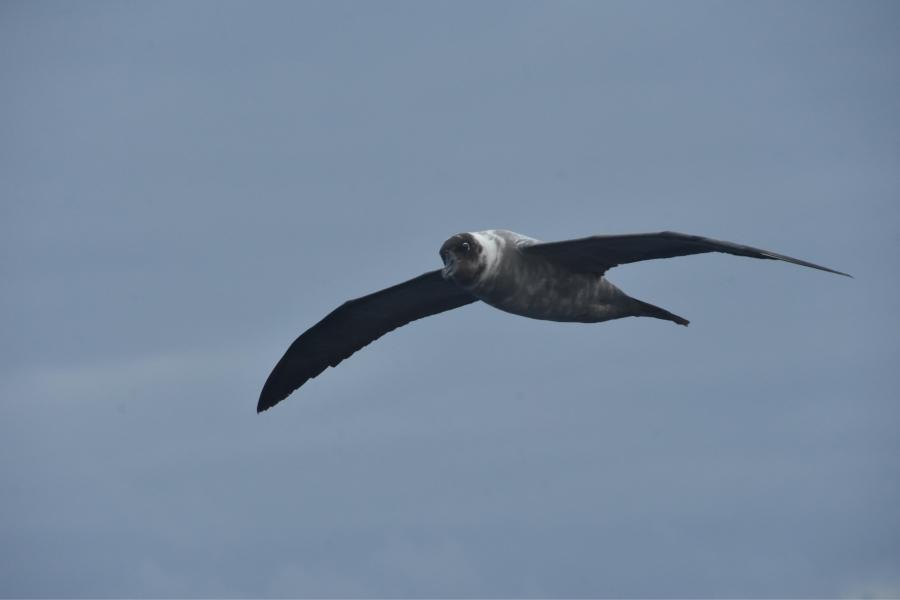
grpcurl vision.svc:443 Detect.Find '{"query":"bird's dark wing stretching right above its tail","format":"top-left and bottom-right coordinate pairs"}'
top-left (522, 231), bottom-right (850, 277)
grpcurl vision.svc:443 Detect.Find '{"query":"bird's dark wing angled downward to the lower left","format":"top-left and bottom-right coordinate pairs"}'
top-left (256, 270), bottom-right (477, 412)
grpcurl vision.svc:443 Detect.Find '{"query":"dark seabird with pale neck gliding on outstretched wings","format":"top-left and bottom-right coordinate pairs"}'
top-left (256, 229), bottom-right (851, 413)
